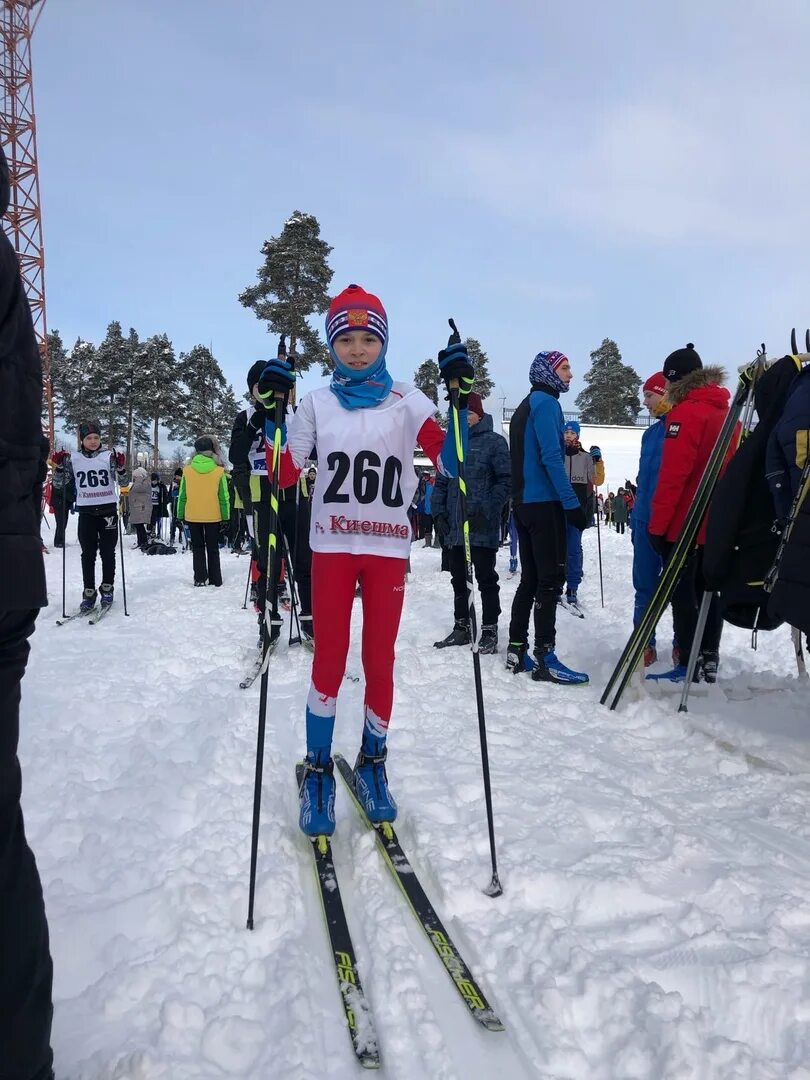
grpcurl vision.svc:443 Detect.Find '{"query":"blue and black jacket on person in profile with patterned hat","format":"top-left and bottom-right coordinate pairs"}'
top-left (509, 387), bottom-right (580, 510)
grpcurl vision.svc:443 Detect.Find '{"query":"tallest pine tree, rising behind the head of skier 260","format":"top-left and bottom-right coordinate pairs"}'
top-left (239, 210), bottom-right (333, 372)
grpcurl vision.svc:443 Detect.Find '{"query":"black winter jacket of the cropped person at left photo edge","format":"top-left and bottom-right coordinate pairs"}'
top-left (0, 150), bottom-right (48, 611)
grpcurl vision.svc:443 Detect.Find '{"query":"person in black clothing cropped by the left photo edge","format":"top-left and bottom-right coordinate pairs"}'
top-left (0, 143), bottom-right (53, 1080)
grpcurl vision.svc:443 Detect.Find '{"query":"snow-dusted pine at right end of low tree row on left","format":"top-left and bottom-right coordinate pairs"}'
top-left (170, 345), bottom-right (240, 444)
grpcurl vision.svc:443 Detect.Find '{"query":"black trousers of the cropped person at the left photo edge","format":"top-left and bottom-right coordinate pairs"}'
top-left (0, 610), bottom-right (53, 1080)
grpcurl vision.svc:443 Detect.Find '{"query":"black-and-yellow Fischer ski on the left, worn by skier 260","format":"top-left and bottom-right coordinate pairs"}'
top-left (295, 764), bottom-right (380, 1069)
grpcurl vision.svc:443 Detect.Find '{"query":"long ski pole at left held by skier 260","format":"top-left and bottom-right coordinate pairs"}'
top-left (247, 334), bottom-right (286, 930)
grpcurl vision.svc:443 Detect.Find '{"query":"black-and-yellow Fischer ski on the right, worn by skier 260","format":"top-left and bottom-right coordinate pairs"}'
top-left (333, 754), bottom-right (503, 1031)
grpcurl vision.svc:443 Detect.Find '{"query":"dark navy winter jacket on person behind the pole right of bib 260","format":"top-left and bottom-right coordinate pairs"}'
top-left (431, 414), bottom-right (510, 548)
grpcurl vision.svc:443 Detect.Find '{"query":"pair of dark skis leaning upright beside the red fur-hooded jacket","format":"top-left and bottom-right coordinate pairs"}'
top-left (600, 346), bottom-right (767, 710)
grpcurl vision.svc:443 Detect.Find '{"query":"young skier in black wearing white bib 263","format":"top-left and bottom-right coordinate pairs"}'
top-left (52, 420), bottom-right (126, 615)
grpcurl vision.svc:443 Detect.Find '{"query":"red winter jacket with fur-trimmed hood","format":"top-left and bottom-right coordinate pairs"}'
top-left (649, 367), bottom-right (734, 544)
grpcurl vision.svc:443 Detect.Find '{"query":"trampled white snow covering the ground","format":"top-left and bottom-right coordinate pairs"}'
top-left (21, 518), bottom-right (810, 1080)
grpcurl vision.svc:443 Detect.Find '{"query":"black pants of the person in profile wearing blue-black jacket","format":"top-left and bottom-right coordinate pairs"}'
top-left (509, 502), bottom-right (567, 654)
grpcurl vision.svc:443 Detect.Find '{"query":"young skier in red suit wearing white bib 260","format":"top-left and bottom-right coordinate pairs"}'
top-left (259, 285), bottom-right (473, 836)
